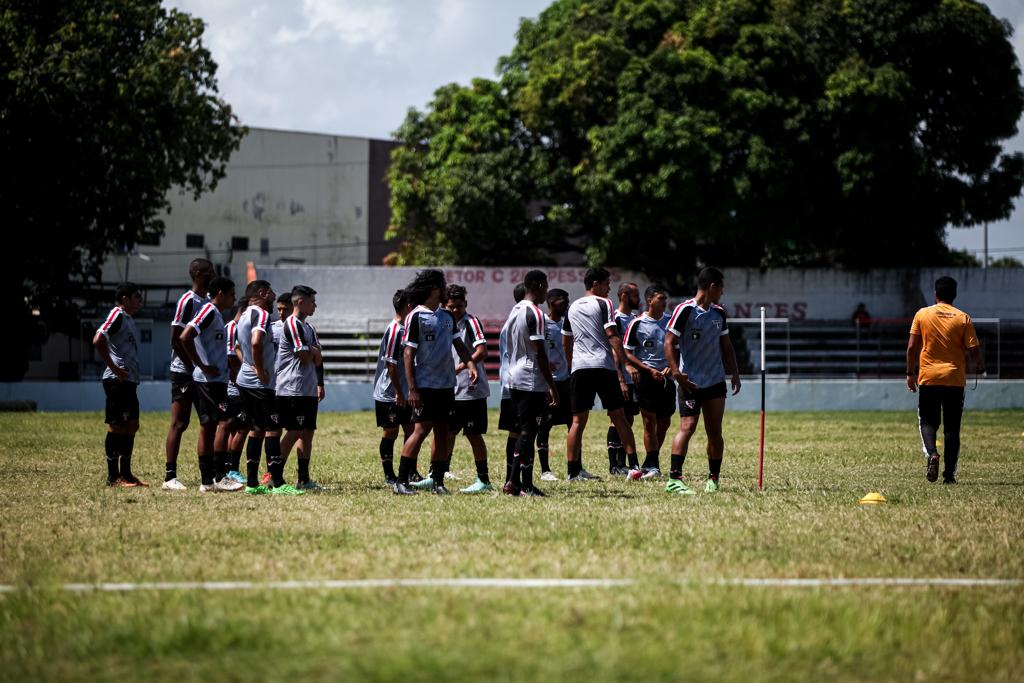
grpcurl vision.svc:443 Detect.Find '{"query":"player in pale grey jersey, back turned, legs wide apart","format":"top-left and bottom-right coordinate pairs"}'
top-left (562, 268), bottom-right (636, 481)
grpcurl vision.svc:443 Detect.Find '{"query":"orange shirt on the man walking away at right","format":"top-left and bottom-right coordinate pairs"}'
top-left (910, 303), bottom-right (978, 386)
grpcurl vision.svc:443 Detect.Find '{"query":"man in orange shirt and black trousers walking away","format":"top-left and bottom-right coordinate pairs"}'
top-left (906, 275), bottom-right (985, 483)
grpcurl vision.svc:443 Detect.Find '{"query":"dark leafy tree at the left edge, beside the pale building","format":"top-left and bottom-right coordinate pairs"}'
top-left (0, 0), bottom-right (245, 378)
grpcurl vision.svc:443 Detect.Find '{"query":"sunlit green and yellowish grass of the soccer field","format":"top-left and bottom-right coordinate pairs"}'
top-left (0, 411), bottom-right (1024, 682)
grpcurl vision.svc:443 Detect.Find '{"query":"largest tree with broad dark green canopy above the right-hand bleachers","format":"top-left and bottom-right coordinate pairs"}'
top-left (387, 0), bottom-right (1024, 282)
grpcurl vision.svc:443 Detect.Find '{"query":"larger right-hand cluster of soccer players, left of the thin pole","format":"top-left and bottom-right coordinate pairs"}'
top-left (374, 268), bottom-right (740, 497)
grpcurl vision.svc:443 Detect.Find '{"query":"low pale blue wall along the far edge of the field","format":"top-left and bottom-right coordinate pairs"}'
top-left (6, 380), bottom-right (1024, 413)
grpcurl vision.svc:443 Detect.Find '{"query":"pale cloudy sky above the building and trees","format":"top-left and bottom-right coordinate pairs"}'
top-left (165, 0), bottom-right (1024, 261)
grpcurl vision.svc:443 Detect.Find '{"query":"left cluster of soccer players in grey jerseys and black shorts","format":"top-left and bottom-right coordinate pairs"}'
top-left (93, 258), bottom-right (325, 496)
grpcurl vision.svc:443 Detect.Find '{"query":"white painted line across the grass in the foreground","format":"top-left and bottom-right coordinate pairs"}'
top-left (0, 578), bottom-right (1024, 593)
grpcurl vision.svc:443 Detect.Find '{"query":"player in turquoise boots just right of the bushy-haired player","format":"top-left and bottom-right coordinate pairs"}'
top-left (444, 285), bottom-right (494, 494)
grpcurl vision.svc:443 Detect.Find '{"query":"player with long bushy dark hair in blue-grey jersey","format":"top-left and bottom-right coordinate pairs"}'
top-left (393, 269), bottom-right (477, 496)
